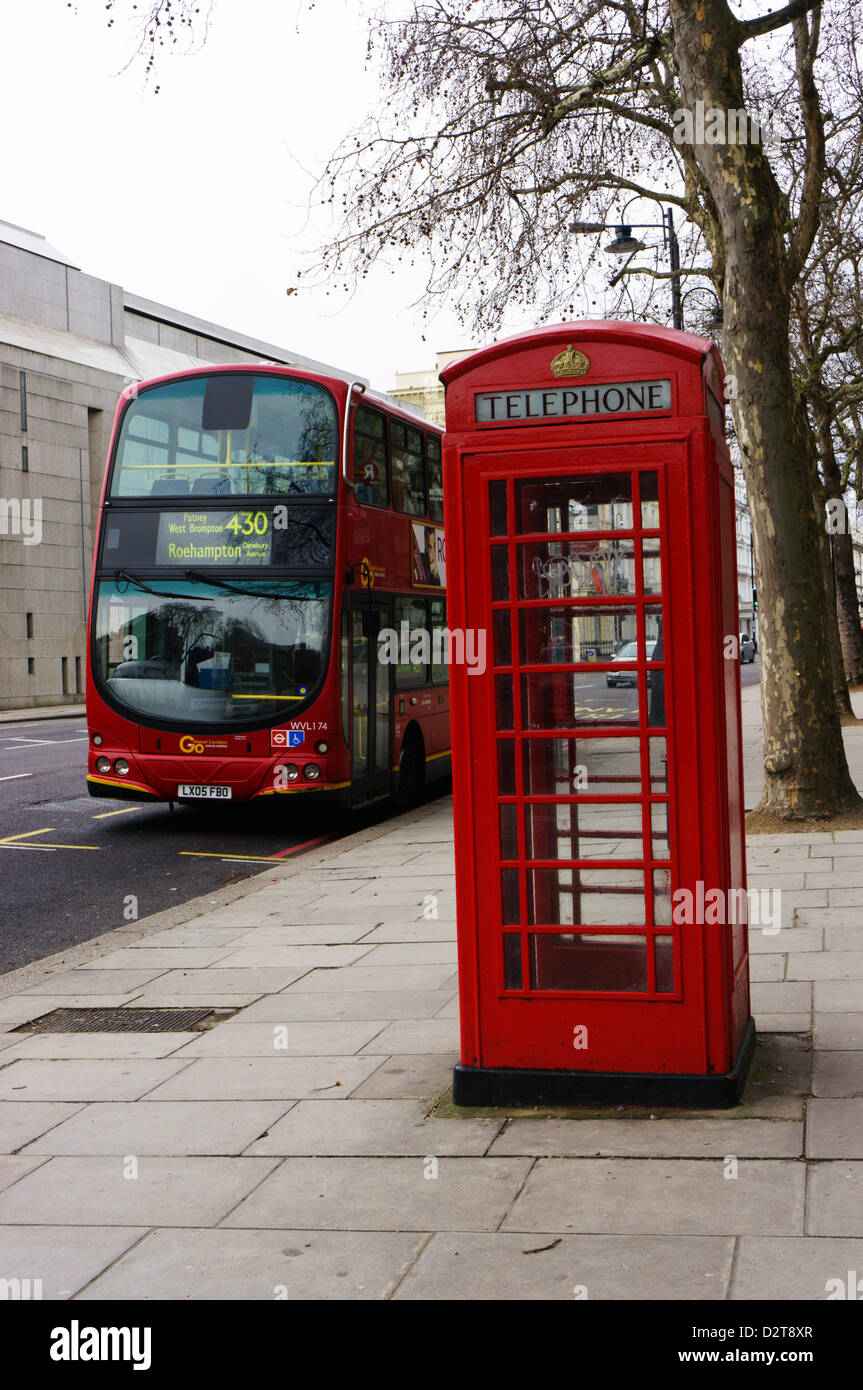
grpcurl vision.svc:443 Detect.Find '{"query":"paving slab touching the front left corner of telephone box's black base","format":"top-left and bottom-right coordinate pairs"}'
top-left (247, 1099), bottom-right (503, 1158)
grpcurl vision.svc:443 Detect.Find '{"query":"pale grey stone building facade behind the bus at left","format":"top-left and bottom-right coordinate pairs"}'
top-left (0, 221), bottom-right (363, 709)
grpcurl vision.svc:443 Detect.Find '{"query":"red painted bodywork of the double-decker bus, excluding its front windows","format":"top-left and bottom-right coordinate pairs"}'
top-left (86, 364), bottom-right (450, 805)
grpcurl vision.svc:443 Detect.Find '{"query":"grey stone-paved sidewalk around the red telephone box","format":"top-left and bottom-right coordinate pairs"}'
top-left (0, 689), bottom-right (863, 1300)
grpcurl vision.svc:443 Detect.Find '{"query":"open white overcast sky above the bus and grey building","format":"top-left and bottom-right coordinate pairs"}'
top-left (0, 0), bottom-right (558, 389)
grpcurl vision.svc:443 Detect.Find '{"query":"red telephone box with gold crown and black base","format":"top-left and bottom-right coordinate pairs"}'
top-left (442, 321), bottom-right (755, 1106)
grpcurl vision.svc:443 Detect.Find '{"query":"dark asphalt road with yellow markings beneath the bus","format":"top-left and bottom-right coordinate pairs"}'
top-left (0, 662), bottom-right (759, 973)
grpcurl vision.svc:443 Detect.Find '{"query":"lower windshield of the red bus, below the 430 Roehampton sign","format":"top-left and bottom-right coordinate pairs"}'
top-left (93, 574), bottom-right (332, 727)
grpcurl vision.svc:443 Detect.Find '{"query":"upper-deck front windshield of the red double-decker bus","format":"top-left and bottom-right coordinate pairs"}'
top-left (110, 371), bottom-right (338, 498)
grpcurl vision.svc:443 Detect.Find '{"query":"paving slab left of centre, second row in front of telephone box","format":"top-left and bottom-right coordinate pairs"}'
top-left (220, 1158), bottom-right (531, 1232)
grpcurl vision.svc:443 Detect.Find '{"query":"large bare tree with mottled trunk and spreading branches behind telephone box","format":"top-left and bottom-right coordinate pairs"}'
top-left (100, 0), bottom-right (860, 820)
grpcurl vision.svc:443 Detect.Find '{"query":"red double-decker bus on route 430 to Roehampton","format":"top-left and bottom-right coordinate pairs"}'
top-left (86, 364), bottom-right (450, 805)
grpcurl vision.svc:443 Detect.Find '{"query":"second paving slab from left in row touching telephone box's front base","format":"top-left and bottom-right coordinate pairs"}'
top-left (25, 1101), bottom-right (293, 1158)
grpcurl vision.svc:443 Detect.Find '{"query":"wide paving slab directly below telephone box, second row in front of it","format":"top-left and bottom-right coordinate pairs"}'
top-left (500, 1158), bottom-right (803, 1236)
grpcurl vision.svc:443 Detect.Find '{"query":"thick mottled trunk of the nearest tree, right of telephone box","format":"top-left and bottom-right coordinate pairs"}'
top-left (670, 0), bottom-right (862, 820)
